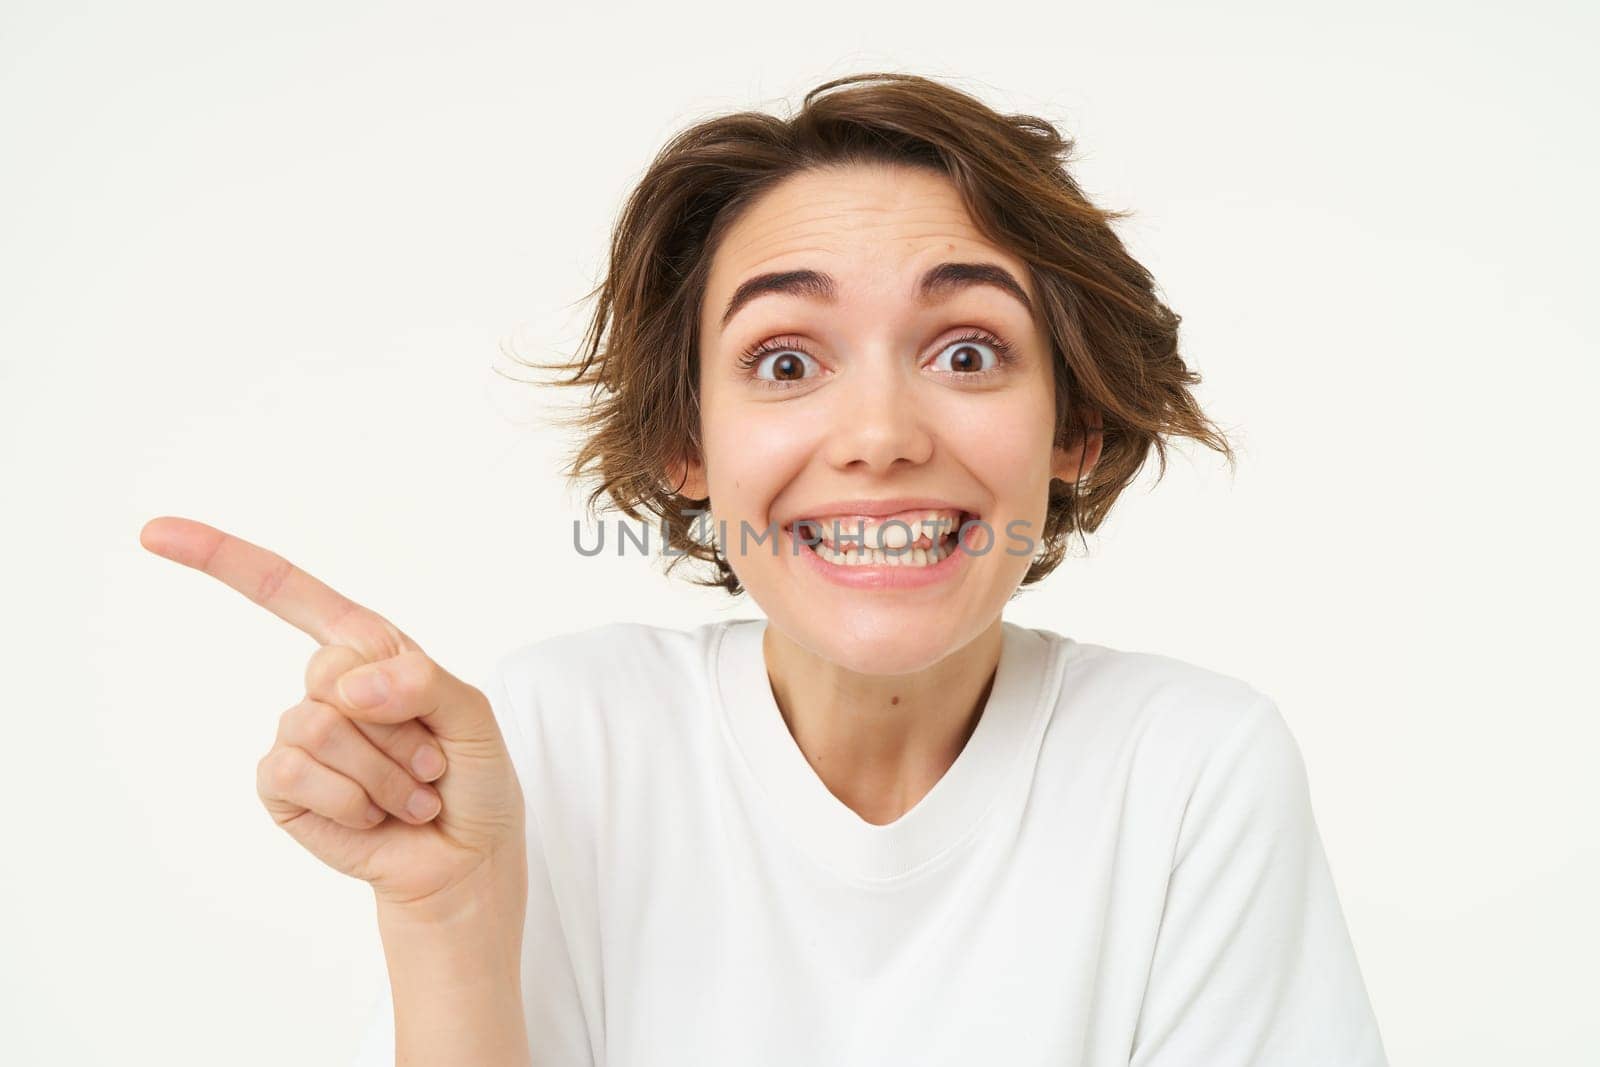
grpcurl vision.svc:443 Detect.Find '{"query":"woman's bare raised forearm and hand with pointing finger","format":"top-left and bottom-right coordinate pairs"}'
top-left (139, 517), bottom-right (528, 1067)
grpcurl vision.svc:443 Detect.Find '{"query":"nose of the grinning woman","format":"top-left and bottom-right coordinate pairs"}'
top-left (822, 354), bottom-right (933, 472)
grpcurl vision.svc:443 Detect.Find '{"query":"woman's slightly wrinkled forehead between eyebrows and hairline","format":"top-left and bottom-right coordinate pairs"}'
top-left (706, 163), bottom-right (1034, 314)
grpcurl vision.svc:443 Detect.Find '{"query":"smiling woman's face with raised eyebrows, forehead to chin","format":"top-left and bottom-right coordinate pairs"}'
top-left (680, 166), bottom-right (1098, 673)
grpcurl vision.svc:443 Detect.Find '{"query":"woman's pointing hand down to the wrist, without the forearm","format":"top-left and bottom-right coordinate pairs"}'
top-left (139, 517), bottom-right (526, 920)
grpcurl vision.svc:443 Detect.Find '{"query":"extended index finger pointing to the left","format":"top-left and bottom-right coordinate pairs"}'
top-left (139, 515), bottom-right (416, 659)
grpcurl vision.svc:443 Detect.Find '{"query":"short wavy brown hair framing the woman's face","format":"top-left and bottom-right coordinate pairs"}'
top-left (518, 74), bottom-right (1235, 593)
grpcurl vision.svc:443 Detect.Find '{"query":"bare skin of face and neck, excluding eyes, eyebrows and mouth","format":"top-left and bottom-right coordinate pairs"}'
top-left (672, 165), bottom-right (1101, 824)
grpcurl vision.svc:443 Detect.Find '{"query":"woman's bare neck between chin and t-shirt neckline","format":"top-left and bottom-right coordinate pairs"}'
top-left (762, 617), bottom-right (1003, 825)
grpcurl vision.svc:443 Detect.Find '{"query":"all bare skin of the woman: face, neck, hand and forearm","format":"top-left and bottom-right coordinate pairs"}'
top-left (139, 156), bottom-right (1099, 1065)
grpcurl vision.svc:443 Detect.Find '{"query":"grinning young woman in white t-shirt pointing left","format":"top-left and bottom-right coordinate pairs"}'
top-left (142, 75), bottom-right (1384, 1067)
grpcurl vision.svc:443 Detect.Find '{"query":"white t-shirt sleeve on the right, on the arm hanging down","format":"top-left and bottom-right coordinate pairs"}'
top-left (1130, 697), bottom-right (1387, 1067)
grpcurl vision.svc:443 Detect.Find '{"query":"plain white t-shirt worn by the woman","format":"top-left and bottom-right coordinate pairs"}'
top-left (360, 619), bottom-right (1386, 1067)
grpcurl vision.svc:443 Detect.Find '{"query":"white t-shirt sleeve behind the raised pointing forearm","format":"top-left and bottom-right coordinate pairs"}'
top-left (352, 661), bottom-right (594, 1067)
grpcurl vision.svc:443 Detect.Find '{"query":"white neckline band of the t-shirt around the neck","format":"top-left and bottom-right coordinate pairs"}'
top-left (712, 619), bottom-right (1058, 881)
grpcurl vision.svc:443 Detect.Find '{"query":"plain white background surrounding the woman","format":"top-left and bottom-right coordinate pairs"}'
top-left (0, 2), bottom-right (1600, 1065)
